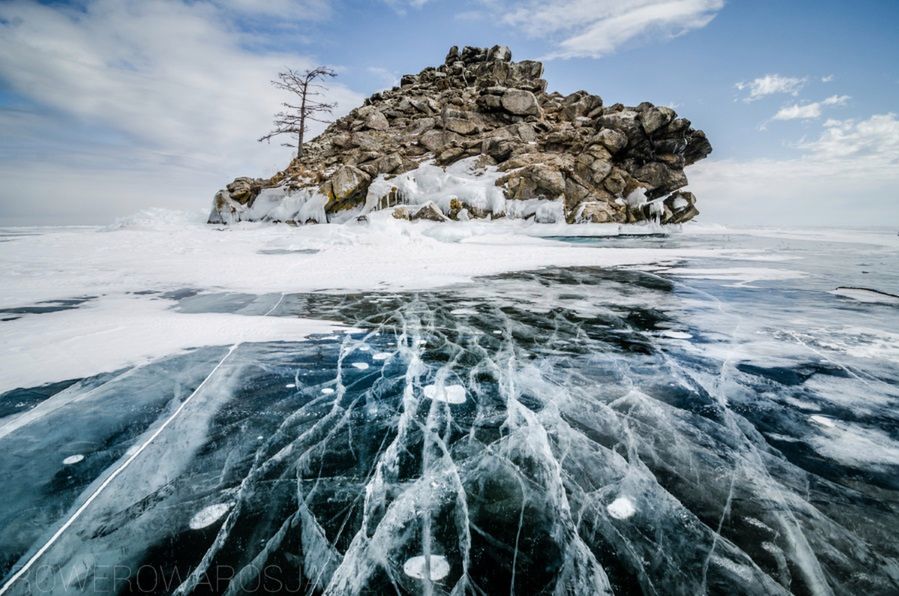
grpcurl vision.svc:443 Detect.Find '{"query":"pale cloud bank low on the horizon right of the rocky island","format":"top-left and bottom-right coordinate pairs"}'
top-left (688, 114), bottom-right (899, 226)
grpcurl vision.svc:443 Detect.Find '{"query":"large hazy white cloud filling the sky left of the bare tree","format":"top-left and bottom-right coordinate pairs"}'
top-left (0, 0), bottom-right (362, 224)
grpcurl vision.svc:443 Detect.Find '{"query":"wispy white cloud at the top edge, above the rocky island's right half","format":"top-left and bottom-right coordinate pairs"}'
top-left (486, 0), bottom-right (724, 58)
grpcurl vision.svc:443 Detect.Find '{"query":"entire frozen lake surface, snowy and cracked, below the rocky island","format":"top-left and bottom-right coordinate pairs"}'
top-left (0, 214), bottom-right (899, 595)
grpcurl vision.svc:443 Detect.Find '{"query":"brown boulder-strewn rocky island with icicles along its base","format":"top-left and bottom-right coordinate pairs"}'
top-left (209, 46), bottom-right (712, 223)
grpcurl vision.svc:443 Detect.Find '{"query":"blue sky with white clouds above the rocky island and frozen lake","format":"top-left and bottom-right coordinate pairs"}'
top-left (0, 0), bottom-right (899, 227)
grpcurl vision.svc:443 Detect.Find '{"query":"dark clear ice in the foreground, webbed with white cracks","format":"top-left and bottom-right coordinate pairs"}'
top-left (0, 268), bottom-right (899, 594)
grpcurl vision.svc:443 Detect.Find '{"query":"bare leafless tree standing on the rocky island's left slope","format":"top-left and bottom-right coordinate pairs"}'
top-left (259, 66), bottom-right (337, 157)
